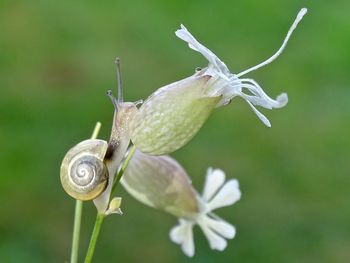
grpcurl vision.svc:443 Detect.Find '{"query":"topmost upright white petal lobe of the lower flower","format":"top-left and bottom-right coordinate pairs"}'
top-left (203, 168), bottom-right (225, 201)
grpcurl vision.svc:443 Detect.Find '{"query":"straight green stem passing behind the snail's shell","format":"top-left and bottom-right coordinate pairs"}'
top-left (70, 122), bottom-right (101, 263)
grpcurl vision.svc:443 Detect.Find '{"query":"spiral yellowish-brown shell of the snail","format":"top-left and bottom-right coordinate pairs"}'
top-left (61, 139), bottom-right (108, 201)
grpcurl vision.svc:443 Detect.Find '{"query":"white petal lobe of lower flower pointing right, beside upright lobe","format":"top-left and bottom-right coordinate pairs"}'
top-left (207, 179), bottom-right (241, 211)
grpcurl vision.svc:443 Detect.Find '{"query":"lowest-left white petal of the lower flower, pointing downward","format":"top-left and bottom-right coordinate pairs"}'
top-left (170, 219), bottom-right (194, 257)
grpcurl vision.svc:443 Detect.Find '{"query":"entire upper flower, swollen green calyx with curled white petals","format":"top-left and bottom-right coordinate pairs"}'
top-left (129, 8), bottom-right (307, 155)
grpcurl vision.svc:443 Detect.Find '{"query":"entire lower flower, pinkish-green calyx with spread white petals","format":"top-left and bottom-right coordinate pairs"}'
top-left (121, 151), bottom-right (241, 257)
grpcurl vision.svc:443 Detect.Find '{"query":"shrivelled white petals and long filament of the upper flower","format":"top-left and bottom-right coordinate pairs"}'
top-left (175, 8), bottom-right (307, 127)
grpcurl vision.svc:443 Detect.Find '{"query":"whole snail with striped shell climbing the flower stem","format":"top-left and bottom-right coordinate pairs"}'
top-left (61, 58), bottom-right (139, 207)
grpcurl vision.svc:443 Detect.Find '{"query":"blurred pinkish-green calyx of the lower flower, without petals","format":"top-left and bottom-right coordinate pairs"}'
top-left (121, 150), bottom-right (199, 217)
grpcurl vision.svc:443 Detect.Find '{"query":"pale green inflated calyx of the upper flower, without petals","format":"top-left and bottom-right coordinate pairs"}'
top-left (130, 74), bottom-right (220, 155)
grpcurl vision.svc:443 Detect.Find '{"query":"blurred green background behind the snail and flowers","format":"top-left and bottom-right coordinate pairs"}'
top-left (0, 0), bottom-right (350, 263)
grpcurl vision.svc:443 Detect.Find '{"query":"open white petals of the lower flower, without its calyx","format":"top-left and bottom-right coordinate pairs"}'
top-left (170, 168), bottom-right (241, 257)
